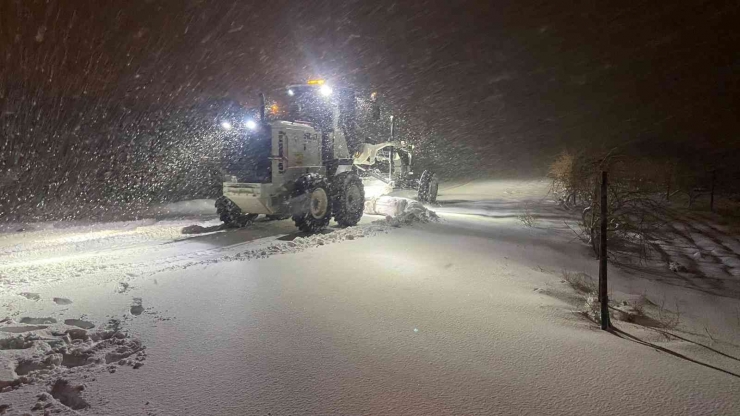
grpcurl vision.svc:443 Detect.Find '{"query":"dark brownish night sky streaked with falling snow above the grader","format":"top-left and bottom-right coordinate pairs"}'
top-left (0, 0), bottom-right (740, 176)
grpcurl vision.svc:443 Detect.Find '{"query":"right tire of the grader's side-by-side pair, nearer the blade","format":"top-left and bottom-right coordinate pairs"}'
top-left (331, 172), bottom-right (365, 227)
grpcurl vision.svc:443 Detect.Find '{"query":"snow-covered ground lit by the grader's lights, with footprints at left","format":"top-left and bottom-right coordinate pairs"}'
top-left (0, 181), bottom-right (740, 415)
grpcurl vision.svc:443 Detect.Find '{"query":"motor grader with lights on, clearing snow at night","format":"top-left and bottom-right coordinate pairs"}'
top-left (215, 80), bottom-right (437, 232)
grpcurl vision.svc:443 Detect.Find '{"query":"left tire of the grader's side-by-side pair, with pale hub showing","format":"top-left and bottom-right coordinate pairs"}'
top-left (291, 174), bottom-right (331, 233)
